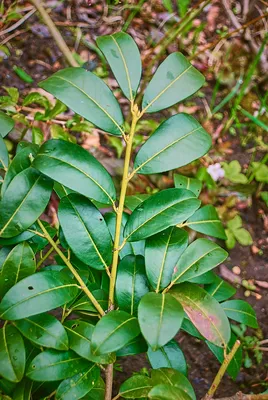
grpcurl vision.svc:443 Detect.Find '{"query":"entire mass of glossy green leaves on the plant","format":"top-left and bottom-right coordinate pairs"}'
top-left (0, 33), bottom-right (257, 400)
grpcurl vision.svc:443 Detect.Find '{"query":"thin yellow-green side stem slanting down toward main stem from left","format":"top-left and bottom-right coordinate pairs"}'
top-left (37, 220), bottom-right (105, 316)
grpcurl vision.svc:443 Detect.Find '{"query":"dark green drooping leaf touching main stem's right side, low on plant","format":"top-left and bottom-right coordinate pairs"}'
top-left (115, 255), bottom-right (149, 315)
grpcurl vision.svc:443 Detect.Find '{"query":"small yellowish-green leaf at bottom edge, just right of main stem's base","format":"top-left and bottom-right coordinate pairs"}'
top-left (119, 375), bottom-right (152, 399)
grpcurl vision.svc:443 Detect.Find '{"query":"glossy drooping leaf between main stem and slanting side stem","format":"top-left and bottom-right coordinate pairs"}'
top-left (58, 193), bottom-right (112, 270)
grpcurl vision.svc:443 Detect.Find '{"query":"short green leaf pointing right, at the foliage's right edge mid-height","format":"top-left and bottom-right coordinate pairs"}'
top-left (185, 204), bottom-right (226, 240)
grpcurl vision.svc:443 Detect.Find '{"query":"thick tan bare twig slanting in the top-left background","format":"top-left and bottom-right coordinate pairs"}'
top-left (31, 0), bottom-right (79, 67)
